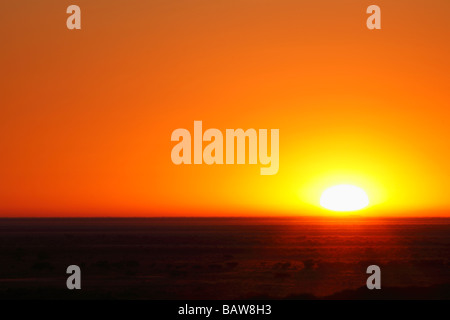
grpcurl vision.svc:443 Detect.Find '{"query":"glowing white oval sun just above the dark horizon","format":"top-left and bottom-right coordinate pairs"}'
top-left (320, 184), bottom-right (369, 211)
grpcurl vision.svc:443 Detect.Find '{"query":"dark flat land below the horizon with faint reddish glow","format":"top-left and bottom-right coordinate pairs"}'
top-left (0, 218), bottom-right (450, 299)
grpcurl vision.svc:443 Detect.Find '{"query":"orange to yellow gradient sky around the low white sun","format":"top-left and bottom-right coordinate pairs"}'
top-left (0, 0), bottom-right (450, 217)
